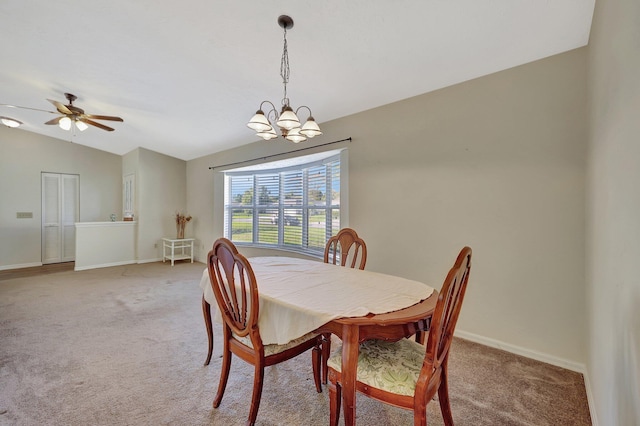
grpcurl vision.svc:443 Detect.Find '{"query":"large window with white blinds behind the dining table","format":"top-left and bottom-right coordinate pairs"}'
top-left (224, 151), bottom-right (344, 256)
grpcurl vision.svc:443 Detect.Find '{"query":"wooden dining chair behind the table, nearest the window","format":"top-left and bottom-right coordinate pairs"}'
top-left (322, 228), bottom-right (367, 384)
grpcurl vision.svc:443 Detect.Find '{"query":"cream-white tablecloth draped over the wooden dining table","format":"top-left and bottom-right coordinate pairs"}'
top-left (200, 257), bottom-right (433, 345)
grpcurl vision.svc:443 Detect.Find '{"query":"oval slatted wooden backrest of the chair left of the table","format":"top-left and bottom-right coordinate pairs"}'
top-left (207, 238), bottom-right (259, 337)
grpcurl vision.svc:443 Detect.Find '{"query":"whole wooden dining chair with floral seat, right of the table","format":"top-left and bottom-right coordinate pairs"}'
top-left (329, 247), bottom-right (471, 426)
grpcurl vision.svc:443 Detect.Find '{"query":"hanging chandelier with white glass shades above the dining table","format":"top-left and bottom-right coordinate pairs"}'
top-left (247, 15), bottom-right (322, 143)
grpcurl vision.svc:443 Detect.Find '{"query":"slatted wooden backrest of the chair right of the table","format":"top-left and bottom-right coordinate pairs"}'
top-left (416, 247), bottom-right (471, 395)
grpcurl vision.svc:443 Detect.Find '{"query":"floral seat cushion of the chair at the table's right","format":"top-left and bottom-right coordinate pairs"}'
top-left (327, 339), bottom-right (425, 396)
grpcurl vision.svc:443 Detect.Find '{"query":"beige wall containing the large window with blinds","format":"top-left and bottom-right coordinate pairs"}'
top-left (187, 49), bottom-right (587, 369)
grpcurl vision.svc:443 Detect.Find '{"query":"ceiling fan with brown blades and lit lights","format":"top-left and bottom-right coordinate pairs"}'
top-left (0, 93), bottom-right (124, 132)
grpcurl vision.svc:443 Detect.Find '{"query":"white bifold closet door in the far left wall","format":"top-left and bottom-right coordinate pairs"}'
top-left (42, 173), bottom-right (80, 264)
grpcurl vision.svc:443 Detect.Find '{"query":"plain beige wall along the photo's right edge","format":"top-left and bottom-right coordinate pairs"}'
top-left (586, 0), bottom-right (640, 426)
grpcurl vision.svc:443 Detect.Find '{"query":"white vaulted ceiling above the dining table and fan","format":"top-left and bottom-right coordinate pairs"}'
top-left (0, 0), bottom-right (595, 160)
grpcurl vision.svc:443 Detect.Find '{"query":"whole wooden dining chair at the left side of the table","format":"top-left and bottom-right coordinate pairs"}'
top-left (207, 238), bottom-right (322, 425)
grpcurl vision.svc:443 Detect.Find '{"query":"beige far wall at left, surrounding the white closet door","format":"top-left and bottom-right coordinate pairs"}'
top-left (0, 126), bottom-right (122, 269)
